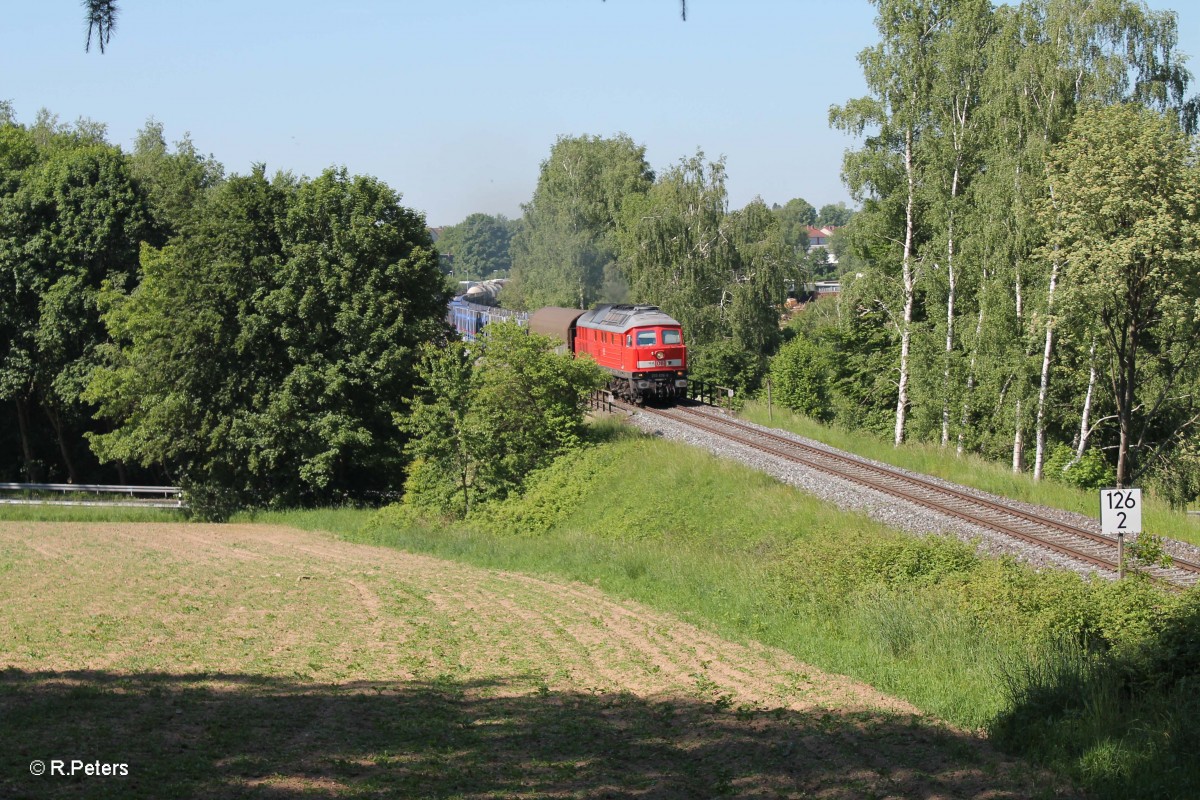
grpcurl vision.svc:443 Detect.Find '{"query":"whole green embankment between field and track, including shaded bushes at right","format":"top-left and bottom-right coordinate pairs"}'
top-left (355, 419), bottom-right (1200, 798)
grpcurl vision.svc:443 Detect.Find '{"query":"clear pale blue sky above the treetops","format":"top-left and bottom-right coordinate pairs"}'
top-left (0, 0), bottom-right (1200, 225)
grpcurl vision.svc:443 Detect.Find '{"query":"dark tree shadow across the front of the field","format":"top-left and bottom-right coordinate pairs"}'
top-left (0, 669), bottom-right (1065, 799)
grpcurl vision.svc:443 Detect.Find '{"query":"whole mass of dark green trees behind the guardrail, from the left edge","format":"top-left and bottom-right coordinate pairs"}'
top-left (0, 106), bottom-right (448, 516)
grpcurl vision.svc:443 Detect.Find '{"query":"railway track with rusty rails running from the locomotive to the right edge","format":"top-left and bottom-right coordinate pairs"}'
top-left (640, 405), bottom-right (1200, 587)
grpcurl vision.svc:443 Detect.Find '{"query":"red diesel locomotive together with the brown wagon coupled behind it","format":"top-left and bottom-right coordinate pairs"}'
top-left (528, 305), bottom-right (688, 403)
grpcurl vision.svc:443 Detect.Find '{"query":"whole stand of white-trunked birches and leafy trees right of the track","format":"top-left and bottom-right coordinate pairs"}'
top-left (799, 0), bottom-right (1200, 504)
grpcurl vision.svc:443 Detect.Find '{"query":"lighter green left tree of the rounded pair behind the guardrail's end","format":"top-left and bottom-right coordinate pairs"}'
top-left (88, 167), bottom-right (295, 506)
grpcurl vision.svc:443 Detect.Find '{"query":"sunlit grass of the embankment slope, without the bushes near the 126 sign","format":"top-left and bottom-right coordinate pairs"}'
top-left (256, 439), bottom-right (1041, 728)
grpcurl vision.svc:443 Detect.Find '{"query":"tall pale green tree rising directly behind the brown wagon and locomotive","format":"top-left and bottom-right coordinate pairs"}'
top-left (505, 133), bottom-right (654, 308)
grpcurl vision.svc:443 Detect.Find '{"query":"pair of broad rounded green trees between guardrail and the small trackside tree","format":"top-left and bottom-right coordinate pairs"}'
top-left (89, 167), bottom-right (448, 512)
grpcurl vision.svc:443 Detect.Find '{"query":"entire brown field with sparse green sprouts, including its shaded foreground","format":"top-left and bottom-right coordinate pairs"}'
top-left (0, 523), bottom-right (1074, 799)
